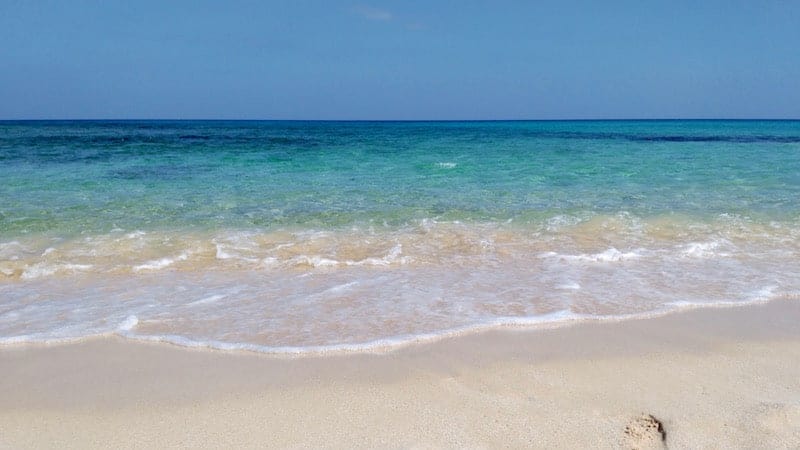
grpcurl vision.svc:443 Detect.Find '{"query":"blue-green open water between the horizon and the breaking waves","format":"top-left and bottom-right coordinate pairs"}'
top-left (0, 121), bottom-right (800, 237)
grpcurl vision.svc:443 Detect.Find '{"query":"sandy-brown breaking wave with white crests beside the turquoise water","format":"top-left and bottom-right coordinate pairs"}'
top-left (0, 214), bottom-right (800, 283)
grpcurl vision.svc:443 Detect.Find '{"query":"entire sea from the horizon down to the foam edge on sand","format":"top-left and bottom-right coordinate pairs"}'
top-left (0, 120), bottom-right (800, 354)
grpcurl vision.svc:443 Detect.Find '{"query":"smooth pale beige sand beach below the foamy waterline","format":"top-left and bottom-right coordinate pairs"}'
top-left (0, 301), bottom-right (800, 448)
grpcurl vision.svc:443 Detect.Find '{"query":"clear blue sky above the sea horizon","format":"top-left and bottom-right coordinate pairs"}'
top-left (0, 0), bottom-right (800, 119)
